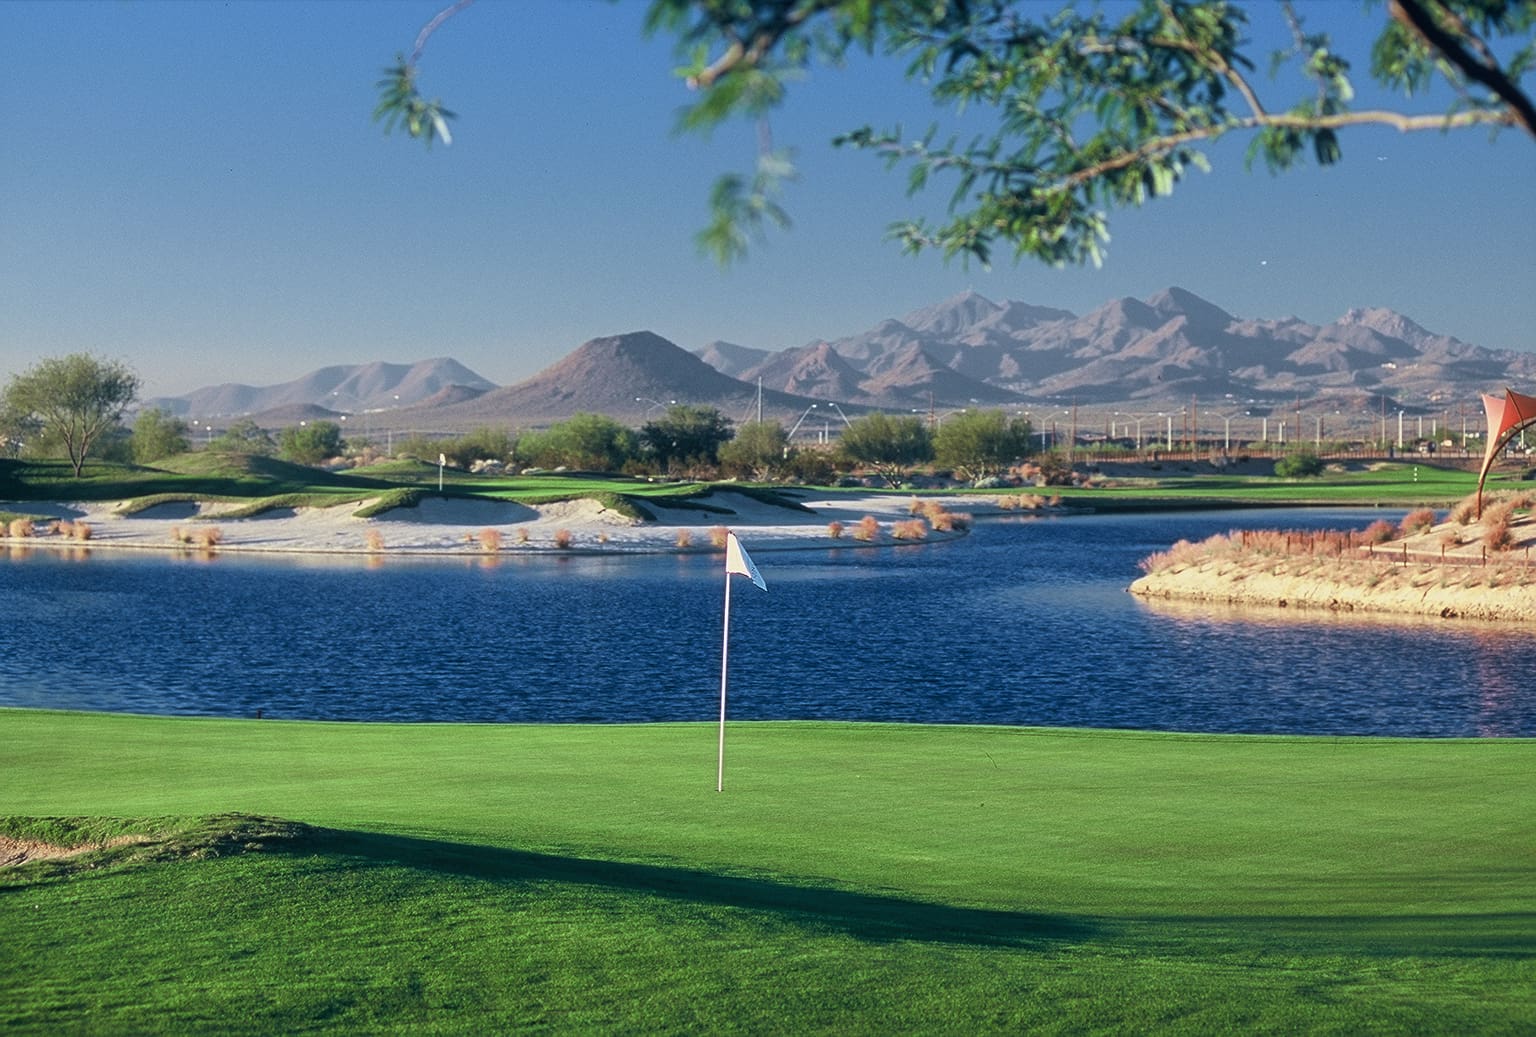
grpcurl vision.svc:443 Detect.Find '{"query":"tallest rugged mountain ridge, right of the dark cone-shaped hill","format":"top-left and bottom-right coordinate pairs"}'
top-left (711, 287), bottom-right (1536, 407)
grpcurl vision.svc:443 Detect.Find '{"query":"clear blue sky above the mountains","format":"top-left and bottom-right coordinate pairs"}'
top-left (0, 0), bottom-right (1536, 395)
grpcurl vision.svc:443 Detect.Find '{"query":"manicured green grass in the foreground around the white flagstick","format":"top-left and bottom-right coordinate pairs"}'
top-left (0, 710), bottom-right (1536, 1034)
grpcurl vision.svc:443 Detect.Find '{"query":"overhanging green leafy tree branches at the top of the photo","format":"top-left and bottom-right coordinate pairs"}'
top-left (375, 0), bottom-right (1536, 264)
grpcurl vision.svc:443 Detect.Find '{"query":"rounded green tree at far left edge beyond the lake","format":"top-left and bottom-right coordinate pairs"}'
top-left (0, 353), bottom-right (138, 479)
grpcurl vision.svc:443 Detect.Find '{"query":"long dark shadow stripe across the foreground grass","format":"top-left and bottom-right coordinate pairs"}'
top-left (314, 828), bottom-right (1100, 946)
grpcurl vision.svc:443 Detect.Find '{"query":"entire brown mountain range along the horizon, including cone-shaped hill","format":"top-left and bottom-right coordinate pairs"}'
top-left (146, 287), bottom-right (1536, 429)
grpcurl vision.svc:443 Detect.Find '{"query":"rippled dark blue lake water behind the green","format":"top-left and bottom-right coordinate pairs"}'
top-left (0, 510), bottom-right (1536, 736)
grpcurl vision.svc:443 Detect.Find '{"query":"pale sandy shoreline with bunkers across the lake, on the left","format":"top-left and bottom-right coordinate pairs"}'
top-left (0, 492), bottom-right (1001, 556)
